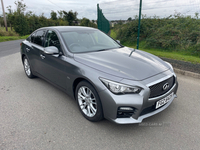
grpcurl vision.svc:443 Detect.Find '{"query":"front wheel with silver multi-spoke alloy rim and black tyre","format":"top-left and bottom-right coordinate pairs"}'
top-left (75, 81), bottom-right (103, 122)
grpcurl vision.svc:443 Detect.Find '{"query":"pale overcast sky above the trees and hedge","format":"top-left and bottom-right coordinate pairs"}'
top-left (0, 0), bottom-right (200, 20)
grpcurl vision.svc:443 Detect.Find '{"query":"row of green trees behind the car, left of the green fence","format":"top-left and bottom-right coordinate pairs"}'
top-left (4, 0), bottom-right (97, 35)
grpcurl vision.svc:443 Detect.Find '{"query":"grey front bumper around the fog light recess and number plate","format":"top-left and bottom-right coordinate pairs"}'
top-left (99, 73), bottom-right (178, 124)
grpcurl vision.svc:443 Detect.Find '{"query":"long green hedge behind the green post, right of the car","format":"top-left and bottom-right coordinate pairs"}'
top-left (114, 13), bottom-right (200, 56)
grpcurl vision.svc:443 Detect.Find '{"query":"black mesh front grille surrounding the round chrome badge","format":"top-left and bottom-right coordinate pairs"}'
top-left (149, 76), bottom-right (175, 98)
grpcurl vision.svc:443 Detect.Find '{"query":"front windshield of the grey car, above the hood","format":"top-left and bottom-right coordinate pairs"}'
top-left (62, 30), bottom-right (121, 53)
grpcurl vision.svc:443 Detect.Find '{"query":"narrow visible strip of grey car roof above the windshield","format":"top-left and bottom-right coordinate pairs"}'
top-left (40, 26), bottom-right (96, 32)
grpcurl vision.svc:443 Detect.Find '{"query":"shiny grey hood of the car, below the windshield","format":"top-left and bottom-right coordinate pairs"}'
top-left (74, 47), bottom-right (170, 80)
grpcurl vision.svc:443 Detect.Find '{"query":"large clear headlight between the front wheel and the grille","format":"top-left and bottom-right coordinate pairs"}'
top-left (100, 78), bottom-right (142, 94)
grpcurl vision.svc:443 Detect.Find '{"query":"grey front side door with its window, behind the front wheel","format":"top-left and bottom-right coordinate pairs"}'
top-left (39, 30), bottom-right (67, 89)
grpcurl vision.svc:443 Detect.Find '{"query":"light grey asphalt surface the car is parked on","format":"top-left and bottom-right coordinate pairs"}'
top-left (0, 42), bottom-right (200, 150)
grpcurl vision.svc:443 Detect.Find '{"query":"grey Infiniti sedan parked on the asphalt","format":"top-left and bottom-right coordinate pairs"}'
top-left (20, 26), bottom-right (178, 124)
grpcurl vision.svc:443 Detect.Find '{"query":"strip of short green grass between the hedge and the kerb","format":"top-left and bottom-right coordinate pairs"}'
top-left (110, 30), bottom-right (200, 64)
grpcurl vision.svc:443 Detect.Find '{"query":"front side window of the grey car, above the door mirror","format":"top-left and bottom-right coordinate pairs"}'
top-left (45, 30), bottom-right (60, 51)
